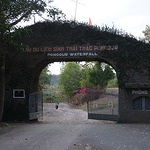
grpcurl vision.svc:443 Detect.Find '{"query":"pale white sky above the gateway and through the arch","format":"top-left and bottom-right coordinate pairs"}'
top-left (47, 0), bottom-right (150, 74)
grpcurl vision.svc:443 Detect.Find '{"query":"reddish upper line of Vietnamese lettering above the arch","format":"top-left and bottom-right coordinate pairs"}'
top-left (27, 45), bottom-right (118, 53)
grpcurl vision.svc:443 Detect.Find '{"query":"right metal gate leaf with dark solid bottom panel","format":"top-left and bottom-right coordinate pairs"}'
top-left (88, 90), bottom-right (118, 121)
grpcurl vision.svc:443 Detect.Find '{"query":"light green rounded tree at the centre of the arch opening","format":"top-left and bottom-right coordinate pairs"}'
top-left (60, 62), bottom-right (81, 96)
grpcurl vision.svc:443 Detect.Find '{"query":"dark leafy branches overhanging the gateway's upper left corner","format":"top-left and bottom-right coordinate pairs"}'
top-left (0, 0), bottom-right (46, 53)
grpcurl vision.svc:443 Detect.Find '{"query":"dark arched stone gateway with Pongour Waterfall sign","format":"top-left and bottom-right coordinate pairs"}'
top-left (4, 22), bottom-right (150, 122)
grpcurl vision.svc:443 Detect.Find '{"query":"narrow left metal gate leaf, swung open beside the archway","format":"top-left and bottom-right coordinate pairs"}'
top-left (29, 92), bottom-right (43, 120)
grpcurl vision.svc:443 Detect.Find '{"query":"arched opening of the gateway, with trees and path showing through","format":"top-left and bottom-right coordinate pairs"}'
top-left (39, 62), bottom-right (118, 120)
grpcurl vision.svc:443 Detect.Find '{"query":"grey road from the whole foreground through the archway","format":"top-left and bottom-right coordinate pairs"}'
top-left (0, 101), bottom-right (150, 150)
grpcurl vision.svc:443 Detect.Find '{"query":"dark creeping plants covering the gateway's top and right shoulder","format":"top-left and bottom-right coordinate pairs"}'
top-left (25, 21), bottom-right (150, 88)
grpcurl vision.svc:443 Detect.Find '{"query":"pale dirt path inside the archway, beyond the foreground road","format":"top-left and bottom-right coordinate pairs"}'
top-left (41, 103), bottom-right (102, 123)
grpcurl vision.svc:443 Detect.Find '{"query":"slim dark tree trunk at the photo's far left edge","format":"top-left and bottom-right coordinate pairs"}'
top-left (0, 56), bottom-right (5, 122)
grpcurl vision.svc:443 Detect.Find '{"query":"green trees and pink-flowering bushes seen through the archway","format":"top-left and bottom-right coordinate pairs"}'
top-left (41, 62), bottom-right (115, 105)
